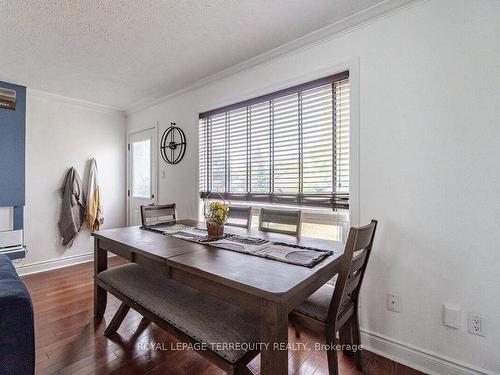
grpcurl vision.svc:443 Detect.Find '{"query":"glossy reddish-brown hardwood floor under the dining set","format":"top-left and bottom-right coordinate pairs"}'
top-left (23, 257), bottom-right (421, 375)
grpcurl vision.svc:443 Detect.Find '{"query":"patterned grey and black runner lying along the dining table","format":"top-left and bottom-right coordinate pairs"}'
top-left (141, 224), bottom-right (333, 268)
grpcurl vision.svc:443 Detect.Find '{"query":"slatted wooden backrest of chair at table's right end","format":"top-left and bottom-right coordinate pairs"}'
top-left (327, 220), bottom-right (377, 330)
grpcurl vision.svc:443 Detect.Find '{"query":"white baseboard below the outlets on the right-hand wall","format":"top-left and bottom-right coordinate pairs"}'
top-left (361, 329), bottom-right (495, 375)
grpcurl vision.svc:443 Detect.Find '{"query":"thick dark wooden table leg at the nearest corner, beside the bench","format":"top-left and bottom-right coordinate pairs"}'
top-left (260, 300), bottom-right (288, 375)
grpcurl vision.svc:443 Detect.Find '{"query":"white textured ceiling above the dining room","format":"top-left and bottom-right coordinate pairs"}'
top-left (0, 0), bottom-right (409, 110)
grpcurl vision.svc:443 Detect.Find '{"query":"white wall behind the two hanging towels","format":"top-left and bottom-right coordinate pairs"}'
top-left (18, 88), bottom-right (126, 274)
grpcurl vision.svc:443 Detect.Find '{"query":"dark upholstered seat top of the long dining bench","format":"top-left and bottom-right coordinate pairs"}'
top-left (97, 264), bottom-right (260, 363)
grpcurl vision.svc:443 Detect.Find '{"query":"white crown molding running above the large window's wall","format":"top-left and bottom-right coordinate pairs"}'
top-left (125, 0), bottom-right (427, 116)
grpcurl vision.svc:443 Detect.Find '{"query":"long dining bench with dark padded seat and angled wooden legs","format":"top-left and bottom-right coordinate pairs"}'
top-left (95, 263), bottom-right (260, 374)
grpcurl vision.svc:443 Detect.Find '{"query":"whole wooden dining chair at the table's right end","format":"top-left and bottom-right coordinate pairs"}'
top-left (289, 220), bottom-right (377, 375)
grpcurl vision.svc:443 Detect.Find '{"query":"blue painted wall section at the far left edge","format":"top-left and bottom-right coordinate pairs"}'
top-left (0, 81), bottom-right (26, 229)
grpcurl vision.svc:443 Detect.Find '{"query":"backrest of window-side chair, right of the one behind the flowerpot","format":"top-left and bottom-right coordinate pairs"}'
top-left (259, 208), bottom-right (302, 237)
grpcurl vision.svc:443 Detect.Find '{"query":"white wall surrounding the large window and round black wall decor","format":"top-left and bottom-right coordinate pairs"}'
top-left (128, 0), bottom-right (500, 374)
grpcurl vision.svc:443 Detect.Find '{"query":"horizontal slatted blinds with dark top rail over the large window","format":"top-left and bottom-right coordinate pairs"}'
top-left (199, 72), bottom-right (349, 209)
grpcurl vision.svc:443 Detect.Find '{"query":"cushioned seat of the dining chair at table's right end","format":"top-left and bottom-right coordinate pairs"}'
top-left (294, 277), bottom-right (351, 323)
